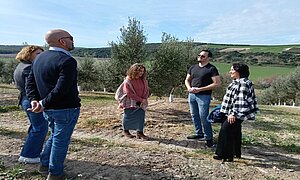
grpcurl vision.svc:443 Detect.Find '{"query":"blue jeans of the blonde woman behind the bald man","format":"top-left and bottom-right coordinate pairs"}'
top-left (20, 97), bottom-right (48, 158)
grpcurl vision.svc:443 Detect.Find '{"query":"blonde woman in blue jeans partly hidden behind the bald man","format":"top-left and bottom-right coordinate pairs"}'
top-left (14, 45), bottom-right (48, 163)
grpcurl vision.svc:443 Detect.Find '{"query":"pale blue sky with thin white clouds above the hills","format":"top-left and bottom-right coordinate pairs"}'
top-left (0, 0), bottom-right (300, 48)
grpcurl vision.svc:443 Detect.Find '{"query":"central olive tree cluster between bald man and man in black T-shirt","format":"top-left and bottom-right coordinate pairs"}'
top-left (79, 18), bottom-right (206, 97)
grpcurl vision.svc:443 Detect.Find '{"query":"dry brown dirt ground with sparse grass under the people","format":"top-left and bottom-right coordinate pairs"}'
top-left (0, 93), bottom-right (300, 180)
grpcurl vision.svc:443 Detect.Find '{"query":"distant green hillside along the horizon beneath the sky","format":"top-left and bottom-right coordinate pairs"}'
top-left (0, 42), bottom-right (300, 66)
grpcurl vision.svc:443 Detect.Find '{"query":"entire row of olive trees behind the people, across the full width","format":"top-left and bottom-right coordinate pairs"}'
top-left (0, 18), bottom-right (300, 104)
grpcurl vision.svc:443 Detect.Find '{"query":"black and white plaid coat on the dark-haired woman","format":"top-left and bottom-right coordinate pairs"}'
top-left (220, 78), bottom-right (258, 120)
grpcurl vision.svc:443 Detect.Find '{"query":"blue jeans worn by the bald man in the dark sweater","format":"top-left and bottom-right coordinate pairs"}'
top-left (41, 108), bottom-right (80, 175)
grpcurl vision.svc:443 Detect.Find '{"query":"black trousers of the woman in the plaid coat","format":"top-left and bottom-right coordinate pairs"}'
top-left (216, 119), bottom-right (243, 159)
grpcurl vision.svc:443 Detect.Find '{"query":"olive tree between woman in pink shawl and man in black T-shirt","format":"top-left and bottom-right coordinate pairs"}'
top-left (149, 33), bottom-right (193, 97)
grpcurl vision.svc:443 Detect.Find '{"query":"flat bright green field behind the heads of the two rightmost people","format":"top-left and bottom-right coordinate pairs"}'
top-left (212, 62), bottom-right (295, 81)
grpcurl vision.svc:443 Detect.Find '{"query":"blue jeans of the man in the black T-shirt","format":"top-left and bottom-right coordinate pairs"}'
top-left (189, 93), bottom-right (213, 140)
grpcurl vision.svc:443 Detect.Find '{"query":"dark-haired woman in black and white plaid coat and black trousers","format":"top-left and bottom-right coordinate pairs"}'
top-left (213, 63), bottom-right (258, 162)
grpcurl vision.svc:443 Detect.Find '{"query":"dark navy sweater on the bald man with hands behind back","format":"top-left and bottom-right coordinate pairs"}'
top-left (26, 50), bottom-right (80, 109)
